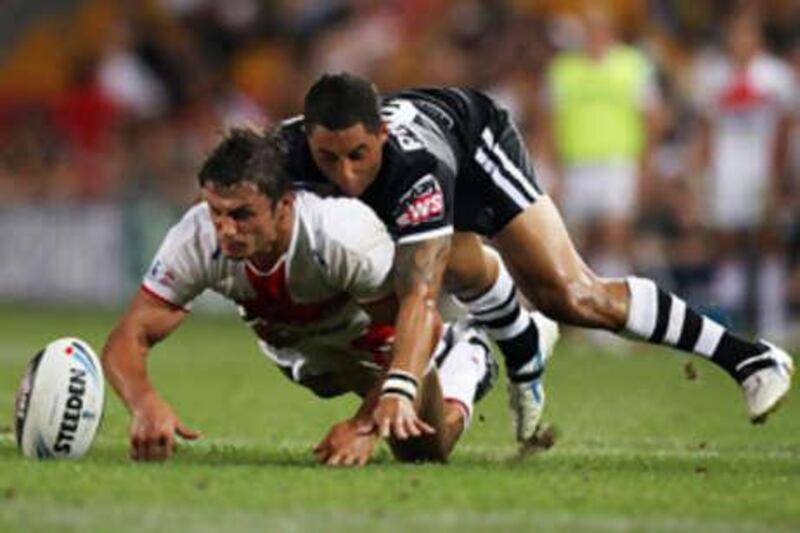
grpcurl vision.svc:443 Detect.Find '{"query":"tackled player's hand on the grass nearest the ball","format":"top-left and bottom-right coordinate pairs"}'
top-left (130, 395), bottom-right (200, 461)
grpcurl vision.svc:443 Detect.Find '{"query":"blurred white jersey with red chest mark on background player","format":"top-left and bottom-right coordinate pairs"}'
top-left (694, 54), bottom-right (797, 185)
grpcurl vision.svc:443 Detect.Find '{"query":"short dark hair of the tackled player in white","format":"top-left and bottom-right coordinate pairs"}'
top-left (198, 128), bottom-right (292, 202)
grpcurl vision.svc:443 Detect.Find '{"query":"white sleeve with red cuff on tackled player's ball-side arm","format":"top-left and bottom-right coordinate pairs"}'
top-left (142, 208), bottom-right (207, 310)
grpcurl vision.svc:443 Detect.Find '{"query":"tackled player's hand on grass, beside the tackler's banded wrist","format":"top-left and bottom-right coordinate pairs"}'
top-left (314, 418), bottom-right (378, 466)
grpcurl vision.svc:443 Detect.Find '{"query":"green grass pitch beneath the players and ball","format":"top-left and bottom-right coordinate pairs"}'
top-left (0, 308), bottom-right (800, 532)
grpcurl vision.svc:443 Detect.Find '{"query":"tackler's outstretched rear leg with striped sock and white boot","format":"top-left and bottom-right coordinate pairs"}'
top-left (496, 197), bottom-right (793, 422)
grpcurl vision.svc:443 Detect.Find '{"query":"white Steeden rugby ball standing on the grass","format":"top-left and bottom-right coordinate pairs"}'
top-left (14, 337), bottom-right (105, 459)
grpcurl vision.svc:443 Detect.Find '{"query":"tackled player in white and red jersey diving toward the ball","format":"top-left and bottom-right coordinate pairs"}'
top-left (103, 129), bottom-right (512, 465)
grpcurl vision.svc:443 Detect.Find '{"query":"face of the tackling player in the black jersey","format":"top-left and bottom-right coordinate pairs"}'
top-left (308, 122), bottom-right (387, 196)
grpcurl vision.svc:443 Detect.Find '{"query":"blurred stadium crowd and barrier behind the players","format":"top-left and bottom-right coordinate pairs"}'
top-left (0, 0), bottom-right (800, 335)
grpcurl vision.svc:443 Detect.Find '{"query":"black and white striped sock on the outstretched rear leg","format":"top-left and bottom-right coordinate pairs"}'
top-left (625, 277), bottom-right (771, 382)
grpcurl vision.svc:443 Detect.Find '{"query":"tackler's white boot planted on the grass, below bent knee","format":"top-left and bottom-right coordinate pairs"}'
top-left (507, 312), bottom-right (559, 443)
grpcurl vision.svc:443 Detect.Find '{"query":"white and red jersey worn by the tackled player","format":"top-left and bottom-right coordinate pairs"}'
top-left (142, 192), bottom-right (394, 380)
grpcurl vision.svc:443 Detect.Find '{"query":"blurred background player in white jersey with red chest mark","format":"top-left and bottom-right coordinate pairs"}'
top-left (692, 6), bottom-right (798, 338)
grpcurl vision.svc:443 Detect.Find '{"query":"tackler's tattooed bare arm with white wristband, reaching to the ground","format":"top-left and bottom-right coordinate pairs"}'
top-left (373, 235), bottom-right (450, 439)
